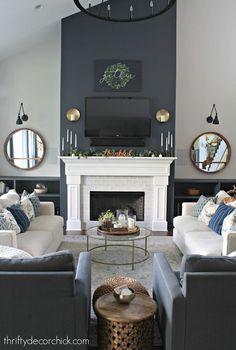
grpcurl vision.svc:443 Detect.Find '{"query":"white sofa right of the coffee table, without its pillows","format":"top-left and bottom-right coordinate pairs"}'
top-left (173, 202), bottom-right (236, 255)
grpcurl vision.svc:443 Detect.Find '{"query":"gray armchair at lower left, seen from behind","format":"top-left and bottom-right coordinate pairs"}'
top-left (0, 252), bottom-right (91, 350)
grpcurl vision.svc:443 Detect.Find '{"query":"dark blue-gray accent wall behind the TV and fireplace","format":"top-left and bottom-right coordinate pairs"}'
top-left (61, 0), bottom-right (176, 226)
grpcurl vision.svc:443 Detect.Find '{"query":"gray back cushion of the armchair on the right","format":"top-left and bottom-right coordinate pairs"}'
top-left (180, 255), bottom-right (236, 288)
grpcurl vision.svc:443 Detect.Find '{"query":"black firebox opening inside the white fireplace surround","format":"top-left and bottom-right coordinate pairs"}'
top-left (90, 191), bottom-right (145, 221)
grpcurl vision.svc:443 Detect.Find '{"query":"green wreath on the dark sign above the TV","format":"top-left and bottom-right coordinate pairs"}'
top-left (99, 62), bottom-right (135, 90)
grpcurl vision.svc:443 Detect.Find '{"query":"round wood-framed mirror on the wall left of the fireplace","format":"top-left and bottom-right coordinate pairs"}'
top-left (4, 128), bottom-right (46, 170)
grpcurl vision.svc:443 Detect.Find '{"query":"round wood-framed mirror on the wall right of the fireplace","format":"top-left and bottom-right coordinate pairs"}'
top-left (190, 131), bottom-right (231, 174)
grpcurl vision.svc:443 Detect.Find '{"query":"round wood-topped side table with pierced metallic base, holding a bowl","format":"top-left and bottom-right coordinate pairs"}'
top-left (95, 293), bottom-right (157, 350)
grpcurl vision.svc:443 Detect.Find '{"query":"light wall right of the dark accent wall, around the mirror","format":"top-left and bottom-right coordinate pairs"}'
top-left (176, 0), bottom-right (236, 179)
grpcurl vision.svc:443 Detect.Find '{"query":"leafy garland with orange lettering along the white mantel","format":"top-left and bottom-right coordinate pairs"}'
top-left (62, 148), bottom-right (174, 158)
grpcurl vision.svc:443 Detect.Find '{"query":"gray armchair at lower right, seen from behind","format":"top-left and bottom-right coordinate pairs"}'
top-left (153, 253), bottom-right (236, 350)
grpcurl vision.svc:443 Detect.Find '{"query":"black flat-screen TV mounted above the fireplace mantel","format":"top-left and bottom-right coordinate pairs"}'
top-left (85, 97), bottom-right (151, 139)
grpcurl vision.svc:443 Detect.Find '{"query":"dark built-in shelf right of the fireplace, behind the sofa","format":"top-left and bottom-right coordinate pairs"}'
top-left (174, 179), bottom-right (236, 216)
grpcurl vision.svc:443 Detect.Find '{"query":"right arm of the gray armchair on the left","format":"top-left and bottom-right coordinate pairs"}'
top-left (75, 252), bottom-right (91, 349)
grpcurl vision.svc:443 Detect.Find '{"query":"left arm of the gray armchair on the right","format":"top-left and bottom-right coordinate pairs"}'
top-left (153, 253), bottom-right (185, 350)
